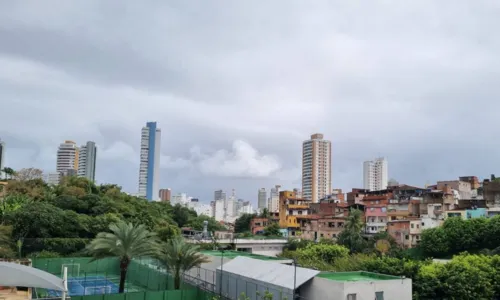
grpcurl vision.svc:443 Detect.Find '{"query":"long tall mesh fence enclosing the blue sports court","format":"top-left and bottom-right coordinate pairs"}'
top-left (29, 258), bottom-right (305, 300)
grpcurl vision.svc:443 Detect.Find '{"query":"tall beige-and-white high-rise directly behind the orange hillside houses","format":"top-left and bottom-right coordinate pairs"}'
top-left (302, 133), bottom-right (332, 203)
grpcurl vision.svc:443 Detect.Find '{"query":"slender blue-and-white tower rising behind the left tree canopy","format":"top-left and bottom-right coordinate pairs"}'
top-left (138, 122), bottom-right (161, 201)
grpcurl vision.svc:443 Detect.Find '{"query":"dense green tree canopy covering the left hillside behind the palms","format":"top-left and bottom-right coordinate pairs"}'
top-left (0, 169), bottom-right (223, 255)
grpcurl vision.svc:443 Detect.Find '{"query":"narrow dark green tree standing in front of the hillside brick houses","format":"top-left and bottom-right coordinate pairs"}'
top-left (338, 209), bottom-right (366, 253)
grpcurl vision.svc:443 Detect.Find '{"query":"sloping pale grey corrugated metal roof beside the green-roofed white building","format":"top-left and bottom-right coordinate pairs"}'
top-left (217, 256), bottom-right (320, 290)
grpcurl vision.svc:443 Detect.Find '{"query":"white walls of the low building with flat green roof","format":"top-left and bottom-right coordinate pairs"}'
top-left (299, 277), bottom-right (412, 300)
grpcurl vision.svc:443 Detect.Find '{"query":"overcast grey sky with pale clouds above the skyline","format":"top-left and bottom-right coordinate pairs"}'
top-left (0, 0), bottom-right (500, 202)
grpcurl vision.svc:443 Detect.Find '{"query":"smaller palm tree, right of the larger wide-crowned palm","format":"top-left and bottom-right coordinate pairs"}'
top-left (158, 237), bottom-right (210, 290)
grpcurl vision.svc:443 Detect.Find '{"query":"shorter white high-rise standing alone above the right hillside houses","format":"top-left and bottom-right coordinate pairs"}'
top-left (363, 157), bottom-right (389, 191)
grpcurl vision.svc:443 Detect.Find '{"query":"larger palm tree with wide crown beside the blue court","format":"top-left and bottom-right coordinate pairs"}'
top-left (87, 221), bottom-right (160, 293)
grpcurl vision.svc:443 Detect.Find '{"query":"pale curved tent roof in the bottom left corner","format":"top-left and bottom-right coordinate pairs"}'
top-left (0, 262), bottom-right (65, 291)
